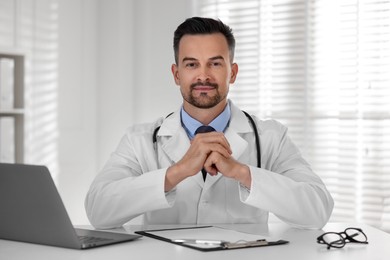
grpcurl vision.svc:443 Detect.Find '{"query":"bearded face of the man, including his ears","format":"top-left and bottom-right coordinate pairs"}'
top-left (172, 33), bottom-right (238, 109)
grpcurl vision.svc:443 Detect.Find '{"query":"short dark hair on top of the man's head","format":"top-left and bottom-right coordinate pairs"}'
top-left (173, 17), bottom-right (236, 64)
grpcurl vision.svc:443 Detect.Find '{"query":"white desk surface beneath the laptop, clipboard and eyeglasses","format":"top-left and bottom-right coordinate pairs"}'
top-left (0, 223), bottom-right (390, 260)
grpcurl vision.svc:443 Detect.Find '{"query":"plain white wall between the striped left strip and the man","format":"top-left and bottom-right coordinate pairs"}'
top-left (59, 0), bottom-right (192, 224)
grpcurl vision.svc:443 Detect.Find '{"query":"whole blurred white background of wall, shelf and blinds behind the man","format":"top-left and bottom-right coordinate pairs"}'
top-left (0, 0), bottom-right (390, 231)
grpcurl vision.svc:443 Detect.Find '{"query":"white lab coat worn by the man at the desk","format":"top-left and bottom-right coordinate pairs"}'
top-left (85, 102), bottom-right (333, 228)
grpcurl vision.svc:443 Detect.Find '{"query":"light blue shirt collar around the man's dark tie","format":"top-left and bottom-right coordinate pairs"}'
top-left (180, 102), bottom-right (231, 139)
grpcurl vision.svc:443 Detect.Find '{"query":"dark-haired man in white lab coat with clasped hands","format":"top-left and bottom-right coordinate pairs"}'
top-left (85, 17), bottom-right (333, 228)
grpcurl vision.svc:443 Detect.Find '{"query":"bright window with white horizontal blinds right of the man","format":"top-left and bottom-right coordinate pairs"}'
top-left (197, 0), bottom-right (390, 230)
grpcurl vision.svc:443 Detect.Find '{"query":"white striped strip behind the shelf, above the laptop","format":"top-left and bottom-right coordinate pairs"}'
top-left (0, 0), bottom-right (59, 177)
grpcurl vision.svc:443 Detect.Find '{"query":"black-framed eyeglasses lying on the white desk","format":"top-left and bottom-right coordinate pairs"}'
top-left (317, 228), bottom-right (368, 249)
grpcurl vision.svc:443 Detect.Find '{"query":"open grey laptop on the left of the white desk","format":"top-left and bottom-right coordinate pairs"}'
top-left (0, 163), bottom-right (141, 249)
